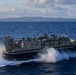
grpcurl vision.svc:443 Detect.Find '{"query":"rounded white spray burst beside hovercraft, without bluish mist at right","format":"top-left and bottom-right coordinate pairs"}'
top-left (40, 48), bottom-right (62, 63)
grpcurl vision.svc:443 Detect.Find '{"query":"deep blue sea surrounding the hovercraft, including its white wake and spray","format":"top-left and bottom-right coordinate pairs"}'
top-left (0, 22), bottom-right (76, 75)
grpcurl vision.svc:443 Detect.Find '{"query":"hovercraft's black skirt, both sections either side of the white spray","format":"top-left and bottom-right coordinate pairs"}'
top-left (3, 46), bottom-right (76, 60)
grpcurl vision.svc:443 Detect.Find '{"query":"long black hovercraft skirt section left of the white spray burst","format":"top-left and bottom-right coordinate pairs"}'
top-left (3, 51), bottom-right (41, 60)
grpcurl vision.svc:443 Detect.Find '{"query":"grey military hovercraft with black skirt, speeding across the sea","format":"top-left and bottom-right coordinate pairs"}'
top-left (3, 33), bottom-right (76, 59)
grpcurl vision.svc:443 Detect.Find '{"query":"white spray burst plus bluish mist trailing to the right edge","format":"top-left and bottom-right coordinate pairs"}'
top-left (39, 48), bottom-right (76, 63)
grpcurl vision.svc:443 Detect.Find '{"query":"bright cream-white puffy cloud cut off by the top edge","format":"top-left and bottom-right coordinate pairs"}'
top-left (23, 0), bottom-right (54, 7)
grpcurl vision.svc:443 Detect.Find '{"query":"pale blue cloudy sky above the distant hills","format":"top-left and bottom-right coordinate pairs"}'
top-left (0, 0), bottom-right (76, 18)
